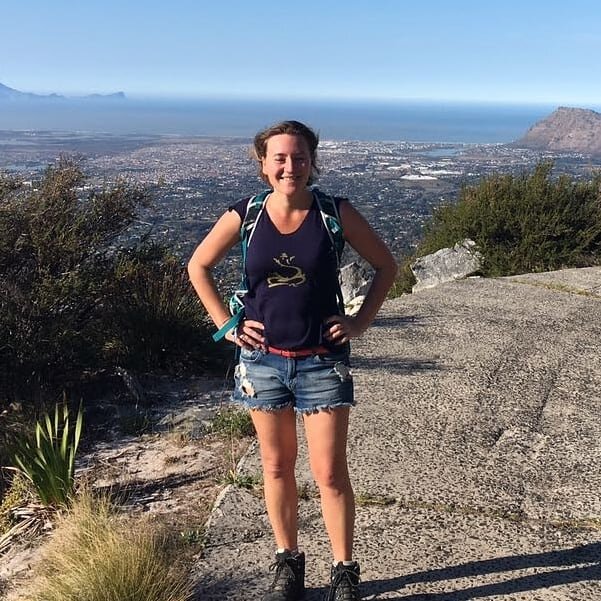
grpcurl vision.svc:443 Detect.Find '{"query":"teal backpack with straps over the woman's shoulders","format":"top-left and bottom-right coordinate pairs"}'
top-left (213, 188), bottom-right (344, 342)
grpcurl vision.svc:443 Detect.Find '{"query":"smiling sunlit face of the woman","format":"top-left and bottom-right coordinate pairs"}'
top-left (261, 134), bottom-right (311, 196)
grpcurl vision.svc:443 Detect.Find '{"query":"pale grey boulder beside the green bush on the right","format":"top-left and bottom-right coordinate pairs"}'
top-left (411, 238), bottom-right (482, 293)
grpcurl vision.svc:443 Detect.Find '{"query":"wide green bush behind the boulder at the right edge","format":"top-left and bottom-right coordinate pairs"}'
top-left (410, 162), bottom-right (601, 276)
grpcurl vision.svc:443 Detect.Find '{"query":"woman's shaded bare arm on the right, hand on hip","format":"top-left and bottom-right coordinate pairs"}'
top-left (326, 201), bottom-right (398, 344)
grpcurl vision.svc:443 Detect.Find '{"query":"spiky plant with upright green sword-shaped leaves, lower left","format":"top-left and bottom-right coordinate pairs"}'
top-left (15, 403), bottom-right (83, 506)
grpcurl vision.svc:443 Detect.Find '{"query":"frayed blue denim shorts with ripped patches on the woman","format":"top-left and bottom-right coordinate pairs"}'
top-left (232, 346), bottom-right (355, 413)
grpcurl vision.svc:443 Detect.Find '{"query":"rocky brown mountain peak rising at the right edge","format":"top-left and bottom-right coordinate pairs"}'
top-left (513, 106), bottom-right (601, 155)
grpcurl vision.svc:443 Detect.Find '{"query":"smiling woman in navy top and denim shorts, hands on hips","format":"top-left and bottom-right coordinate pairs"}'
top-left (188, 121), bottom-right (396, 601)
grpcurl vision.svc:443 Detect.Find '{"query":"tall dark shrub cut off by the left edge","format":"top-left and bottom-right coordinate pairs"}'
top-left (0, 160), bottom-right (149, 398)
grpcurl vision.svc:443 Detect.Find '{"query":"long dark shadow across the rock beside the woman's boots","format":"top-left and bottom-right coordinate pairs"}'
top-left (363, 543), bottom-right (601, 601)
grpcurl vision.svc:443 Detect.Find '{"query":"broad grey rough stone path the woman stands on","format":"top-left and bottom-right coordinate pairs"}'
top-left (195, 268), bottom-right (601, 601)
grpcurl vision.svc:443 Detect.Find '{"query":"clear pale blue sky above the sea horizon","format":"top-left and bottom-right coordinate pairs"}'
top-left (0, 0), bottom-right (601, 107)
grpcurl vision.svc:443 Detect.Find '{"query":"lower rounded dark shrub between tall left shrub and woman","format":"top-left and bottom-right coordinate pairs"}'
top-left (103, 243), bottom-right (219, 372)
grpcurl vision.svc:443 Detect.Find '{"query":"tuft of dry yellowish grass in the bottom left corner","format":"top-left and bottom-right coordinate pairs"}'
top-left (21, 493), bottom-right (191, 601)
